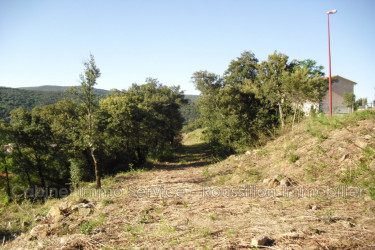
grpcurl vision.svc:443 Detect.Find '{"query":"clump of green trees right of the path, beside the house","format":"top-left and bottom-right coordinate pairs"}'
top-left (194, 51), bottom-right (326, 152)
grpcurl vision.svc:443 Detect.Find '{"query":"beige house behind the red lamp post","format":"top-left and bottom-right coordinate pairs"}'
top-left (303, 75), bottom-right (357, 114)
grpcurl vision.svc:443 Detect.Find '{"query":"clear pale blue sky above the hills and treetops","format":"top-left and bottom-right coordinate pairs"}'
top-left (0, 0), bottom-right (375, 101)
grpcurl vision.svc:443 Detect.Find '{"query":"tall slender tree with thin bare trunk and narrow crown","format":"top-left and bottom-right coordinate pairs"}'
top-left (70, 54), bottom-right (101, 188)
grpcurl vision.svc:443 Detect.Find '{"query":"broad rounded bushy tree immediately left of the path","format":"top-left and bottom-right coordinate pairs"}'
top-left (99, 78), bottom-right (186, 166)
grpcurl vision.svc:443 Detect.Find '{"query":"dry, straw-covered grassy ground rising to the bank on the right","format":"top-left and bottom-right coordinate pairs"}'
top-left (3, 111), bottom-right (375, 249)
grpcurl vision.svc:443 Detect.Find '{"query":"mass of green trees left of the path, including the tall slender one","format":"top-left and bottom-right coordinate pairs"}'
top-left (0, 55), bottom-right (188, 198)
